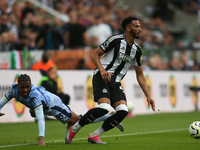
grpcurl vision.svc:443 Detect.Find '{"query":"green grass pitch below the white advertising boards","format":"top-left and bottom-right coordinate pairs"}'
top-left (0, 112), bottom-right (200, 150)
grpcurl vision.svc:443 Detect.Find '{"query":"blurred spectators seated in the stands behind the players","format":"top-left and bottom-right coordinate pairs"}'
top-left (0, 0), bottom-right (200, 70)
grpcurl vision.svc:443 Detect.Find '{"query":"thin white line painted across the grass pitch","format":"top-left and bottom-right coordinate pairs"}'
top-left (0, 128), bottom-right (188, 148)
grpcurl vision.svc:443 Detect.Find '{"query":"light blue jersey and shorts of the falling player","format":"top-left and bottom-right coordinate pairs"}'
top-left (0, 83), bottom-right (71, 136)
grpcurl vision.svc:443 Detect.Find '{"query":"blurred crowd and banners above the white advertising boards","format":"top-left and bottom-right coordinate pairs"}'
top-left (0, 0), bottom-right (200, 70)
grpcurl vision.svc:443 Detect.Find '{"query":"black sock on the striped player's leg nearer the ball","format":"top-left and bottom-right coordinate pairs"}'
top-left (102, 110), bottom-right (128, 131)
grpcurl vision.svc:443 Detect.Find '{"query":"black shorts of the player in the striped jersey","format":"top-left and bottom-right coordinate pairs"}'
top-left (92, 72), bottom-right (126, 106)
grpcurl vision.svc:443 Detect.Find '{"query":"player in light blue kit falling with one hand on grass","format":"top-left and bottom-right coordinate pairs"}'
top-left (0, 74), bottom-right (123, 145)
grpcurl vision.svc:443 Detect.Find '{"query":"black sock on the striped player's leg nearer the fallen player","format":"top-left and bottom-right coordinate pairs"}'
top-left (79, 107), bottom-right (108, 127)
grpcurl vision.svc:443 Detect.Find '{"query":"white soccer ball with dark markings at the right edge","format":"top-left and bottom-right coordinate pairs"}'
top-left (189, 121), bottom-right (200, 139)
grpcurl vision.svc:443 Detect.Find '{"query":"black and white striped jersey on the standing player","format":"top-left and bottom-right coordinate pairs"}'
top-left (94, 34), bottom-right (142, 82)
